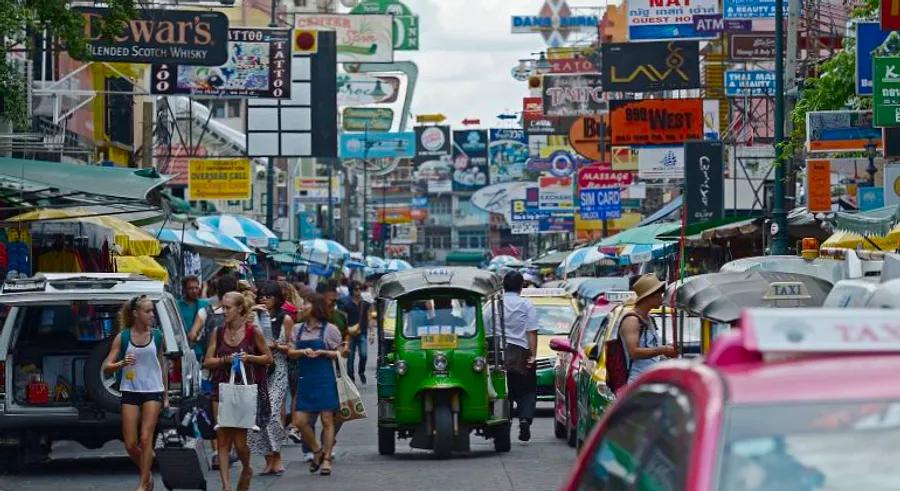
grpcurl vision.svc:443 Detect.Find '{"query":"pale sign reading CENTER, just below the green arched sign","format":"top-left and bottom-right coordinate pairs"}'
top-left (294, 14), bottom-right (394, 63)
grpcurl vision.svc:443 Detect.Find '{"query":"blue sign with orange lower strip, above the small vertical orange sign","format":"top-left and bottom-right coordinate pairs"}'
top-left (806, 111), bottom-right (882, 152)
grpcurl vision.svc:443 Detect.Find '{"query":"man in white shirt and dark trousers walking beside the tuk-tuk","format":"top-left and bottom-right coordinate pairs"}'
top-left (503, 271), bottom-right (538, 442)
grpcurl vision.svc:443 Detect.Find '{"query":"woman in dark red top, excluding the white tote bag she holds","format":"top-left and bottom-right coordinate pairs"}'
top-left (203, 292), bottom-right (272, 491)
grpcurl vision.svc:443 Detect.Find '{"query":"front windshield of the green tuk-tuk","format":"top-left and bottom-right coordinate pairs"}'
top-left (403, 297), bottom-right (477, 338)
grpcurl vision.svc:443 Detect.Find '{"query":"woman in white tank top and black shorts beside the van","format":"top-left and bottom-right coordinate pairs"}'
top-left (103, 296), bottom-right (169, 491)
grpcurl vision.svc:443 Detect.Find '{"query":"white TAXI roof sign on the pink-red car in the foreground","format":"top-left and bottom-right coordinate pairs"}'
top-left (741, 308), bottom-right (900, 353)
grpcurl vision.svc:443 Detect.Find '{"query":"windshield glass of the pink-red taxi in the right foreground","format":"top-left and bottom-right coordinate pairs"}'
top-left (719, 401), bottom-right (900, 491)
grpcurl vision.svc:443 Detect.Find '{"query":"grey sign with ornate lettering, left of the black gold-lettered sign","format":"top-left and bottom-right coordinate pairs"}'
top-left (542, 74), bottom-right (609, 116)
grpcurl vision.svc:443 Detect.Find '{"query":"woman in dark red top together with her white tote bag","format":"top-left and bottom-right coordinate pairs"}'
top-left (203, 292), bottom-right (272, 491)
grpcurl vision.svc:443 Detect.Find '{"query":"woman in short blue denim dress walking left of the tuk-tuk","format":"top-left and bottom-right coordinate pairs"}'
top-left (280, 294), bottom-right (342, 476)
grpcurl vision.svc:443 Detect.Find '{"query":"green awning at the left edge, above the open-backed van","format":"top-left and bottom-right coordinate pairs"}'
top-left (0, 157), bottom-right (171, 200)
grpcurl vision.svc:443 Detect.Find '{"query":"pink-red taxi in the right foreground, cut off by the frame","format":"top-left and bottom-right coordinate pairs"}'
top-left (561, 309), bottom-right (900, 491)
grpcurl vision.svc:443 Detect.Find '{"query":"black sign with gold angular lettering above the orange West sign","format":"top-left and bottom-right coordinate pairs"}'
top-left (603, 41), bottom-right (701, 92)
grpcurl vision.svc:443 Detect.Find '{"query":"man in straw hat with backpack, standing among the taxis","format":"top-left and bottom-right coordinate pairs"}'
top-left (619, 274), bottom-right (678, 383)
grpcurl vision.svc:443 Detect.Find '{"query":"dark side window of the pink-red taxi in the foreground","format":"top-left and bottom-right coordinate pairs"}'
top-left (578, 385), bottom-right (694, 491)
